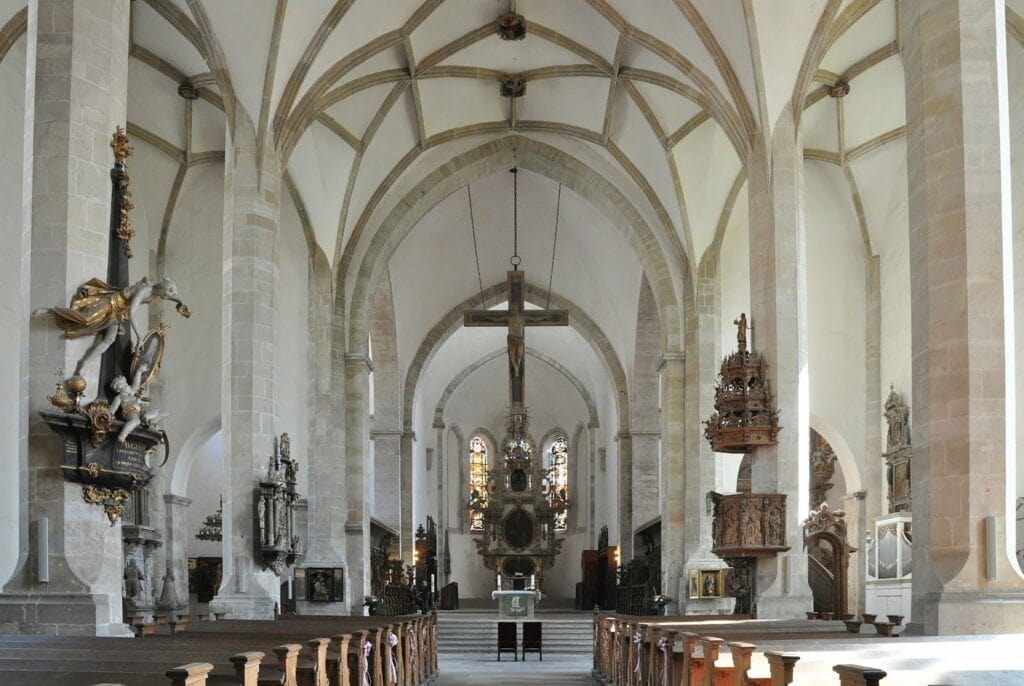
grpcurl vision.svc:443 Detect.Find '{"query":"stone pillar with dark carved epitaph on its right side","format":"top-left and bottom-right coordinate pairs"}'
top-left (210, 111), bottom-right (281, 619)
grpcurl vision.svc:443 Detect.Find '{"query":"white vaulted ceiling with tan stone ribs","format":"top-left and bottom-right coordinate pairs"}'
top-left (0, 0), bottom-right (946, 436)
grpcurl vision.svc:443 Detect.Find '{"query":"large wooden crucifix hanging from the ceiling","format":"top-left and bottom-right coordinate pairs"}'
top-left (463, 270), bottom-right (569, 415)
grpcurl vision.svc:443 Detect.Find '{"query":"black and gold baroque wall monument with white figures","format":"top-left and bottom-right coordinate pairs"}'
top-left (33, 127), bottom-right (191, 525)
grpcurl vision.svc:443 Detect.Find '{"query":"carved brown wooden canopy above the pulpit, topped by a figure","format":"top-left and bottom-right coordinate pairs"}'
top-left (705, 313), bottom-right (781, 453)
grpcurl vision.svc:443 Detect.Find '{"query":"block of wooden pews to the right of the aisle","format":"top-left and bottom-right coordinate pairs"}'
top-left (593, 612), bottom-right (886, 686)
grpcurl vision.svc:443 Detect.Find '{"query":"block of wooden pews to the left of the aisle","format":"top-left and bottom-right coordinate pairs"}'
top-left (0, 614), bottom-right (437, 686)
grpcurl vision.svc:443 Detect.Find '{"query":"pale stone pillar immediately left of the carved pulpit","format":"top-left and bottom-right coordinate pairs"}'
top-left (679, 268), bottom-right (739, 614)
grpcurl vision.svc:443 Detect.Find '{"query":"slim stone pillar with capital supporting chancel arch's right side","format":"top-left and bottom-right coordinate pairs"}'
top-left (658, 351), bottom-right (686, 598)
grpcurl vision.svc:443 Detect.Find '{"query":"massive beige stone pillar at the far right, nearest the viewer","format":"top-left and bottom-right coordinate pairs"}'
top-left (900, 0), bottom-right (1024, 634)
